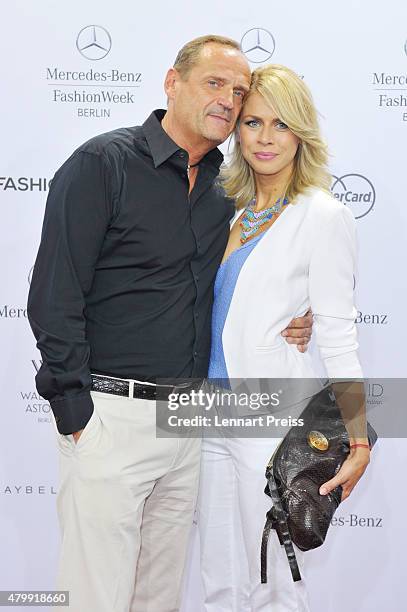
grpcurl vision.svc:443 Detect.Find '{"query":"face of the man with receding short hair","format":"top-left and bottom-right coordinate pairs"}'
top-left (167, 43), bottom-right (250, 147)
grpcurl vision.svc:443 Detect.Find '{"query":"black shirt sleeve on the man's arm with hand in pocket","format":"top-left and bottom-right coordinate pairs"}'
top-left (28, 151), bottom-right (114, 434)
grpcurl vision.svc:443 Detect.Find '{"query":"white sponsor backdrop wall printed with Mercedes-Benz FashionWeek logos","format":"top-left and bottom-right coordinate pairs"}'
top-left (0, 0), bottom-right (407, 612)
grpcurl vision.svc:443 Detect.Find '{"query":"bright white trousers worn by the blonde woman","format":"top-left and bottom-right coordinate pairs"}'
top-left (198, 437), bottom-right (309, 612)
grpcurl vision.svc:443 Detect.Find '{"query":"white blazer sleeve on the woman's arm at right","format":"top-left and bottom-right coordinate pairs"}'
top-left (309, 204), bottom-right (363, 378)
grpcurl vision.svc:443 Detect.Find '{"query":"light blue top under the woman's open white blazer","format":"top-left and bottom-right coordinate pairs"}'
top-left (208, 232), bottom-right (265, 380)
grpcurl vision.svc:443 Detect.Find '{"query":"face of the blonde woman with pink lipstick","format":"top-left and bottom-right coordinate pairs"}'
top-left (239, 93), bottom-right (300, 181)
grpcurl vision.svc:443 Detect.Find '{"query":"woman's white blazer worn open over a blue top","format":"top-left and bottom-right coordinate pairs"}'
top-left (222, 189), bottom-right (363, 378)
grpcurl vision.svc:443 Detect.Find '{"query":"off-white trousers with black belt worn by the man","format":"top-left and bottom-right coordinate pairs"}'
top-left (56, 392), bottom-right (201, 612)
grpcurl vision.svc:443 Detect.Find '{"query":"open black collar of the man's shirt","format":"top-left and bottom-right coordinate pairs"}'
top-left (143, 109), bottom-right (223, 170)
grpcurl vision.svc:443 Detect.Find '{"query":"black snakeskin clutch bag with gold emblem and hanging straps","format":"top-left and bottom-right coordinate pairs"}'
top-left (261, 386), bottom-right (377, 583)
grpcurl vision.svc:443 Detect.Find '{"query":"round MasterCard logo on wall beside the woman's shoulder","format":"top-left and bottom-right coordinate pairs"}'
top-left (331, 172), bottom-right (376, 219)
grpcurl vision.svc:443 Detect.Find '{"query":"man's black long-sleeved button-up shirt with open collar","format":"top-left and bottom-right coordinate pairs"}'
top-left (28, 111), bottom-right (233, 433)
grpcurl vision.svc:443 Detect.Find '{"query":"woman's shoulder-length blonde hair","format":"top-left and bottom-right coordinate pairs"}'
top-left (220, 64), bottom-right (331, 208)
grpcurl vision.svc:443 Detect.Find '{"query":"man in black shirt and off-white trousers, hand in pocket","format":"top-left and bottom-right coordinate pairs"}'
top-left (28, 36), bottom-right (310, 612)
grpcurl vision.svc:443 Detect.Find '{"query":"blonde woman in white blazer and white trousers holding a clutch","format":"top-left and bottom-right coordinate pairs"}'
top-left (198, 65), bottom-right (369, 612)
